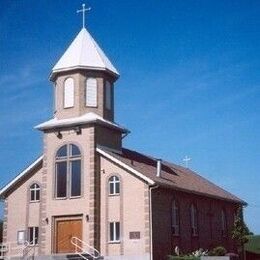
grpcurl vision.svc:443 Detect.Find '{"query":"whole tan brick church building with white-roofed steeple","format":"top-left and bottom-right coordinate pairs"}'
top-left (0, 6), bottom-right (246, 260)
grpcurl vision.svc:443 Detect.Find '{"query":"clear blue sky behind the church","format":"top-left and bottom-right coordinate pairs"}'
top-left (0, 0), bottom-right (260, 234)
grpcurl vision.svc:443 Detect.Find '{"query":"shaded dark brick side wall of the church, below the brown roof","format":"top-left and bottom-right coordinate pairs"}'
top-left (152, 189), bottom-right (238, 260)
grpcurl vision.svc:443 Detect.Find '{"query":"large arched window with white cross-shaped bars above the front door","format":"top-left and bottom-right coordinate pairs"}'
top-left (56, 144), bottom-right (81, 198)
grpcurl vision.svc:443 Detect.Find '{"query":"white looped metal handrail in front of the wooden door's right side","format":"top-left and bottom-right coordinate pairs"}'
top-left (70, 237), bottom-right (100, 259)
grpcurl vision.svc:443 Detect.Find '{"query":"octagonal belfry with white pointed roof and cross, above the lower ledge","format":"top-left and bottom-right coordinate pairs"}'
top-left (50, 13), bottom-right (119, 121)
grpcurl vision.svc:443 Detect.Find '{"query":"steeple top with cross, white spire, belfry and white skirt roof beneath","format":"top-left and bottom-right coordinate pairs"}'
top-left (36, 4), bottom-right (128, 149)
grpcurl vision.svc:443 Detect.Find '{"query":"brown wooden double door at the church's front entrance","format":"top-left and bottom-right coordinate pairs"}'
top-left (55, 219), bottom-right (82, 253)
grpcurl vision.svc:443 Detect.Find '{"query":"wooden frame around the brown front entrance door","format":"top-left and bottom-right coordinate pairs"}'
top-left (51, 214), bottom-right (83, 254)
